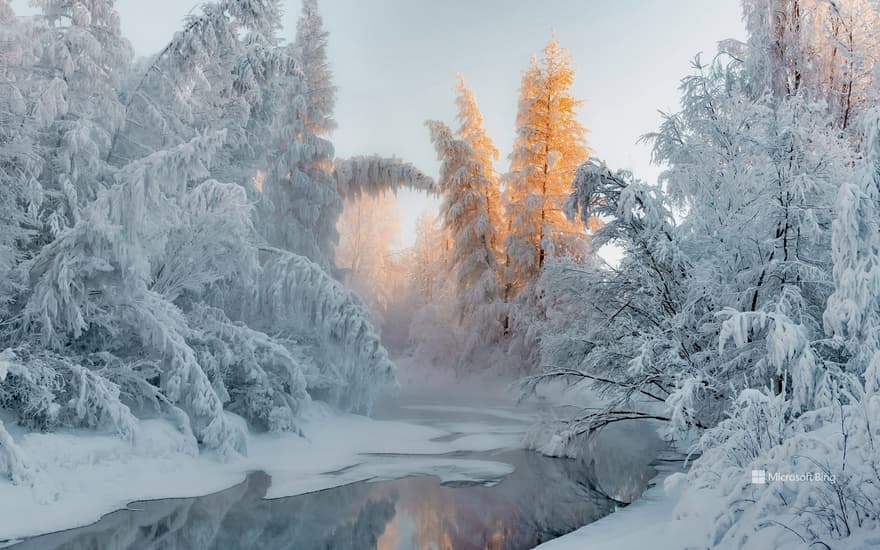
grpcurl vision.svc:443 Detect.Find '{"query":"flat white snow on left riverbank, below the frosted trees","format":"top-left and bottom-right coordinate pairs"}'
top-left (0, 405), bottom-right (527, 545)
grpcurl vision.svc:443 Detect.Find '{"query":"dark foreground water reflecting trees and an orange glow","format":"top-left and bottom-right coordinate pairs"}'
top-left (14, 451), bottom-right (628, 550)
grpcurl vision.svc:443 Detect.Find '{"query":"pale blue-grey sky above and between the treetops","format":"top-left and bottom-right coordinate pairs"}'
top-left (13, 0), bottom-right (745, 246)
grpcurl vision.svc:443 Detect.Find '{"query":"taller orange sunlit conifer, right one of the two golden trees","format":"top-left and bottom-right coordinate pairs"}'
top-left (504, 36), bottom-right (589, 298)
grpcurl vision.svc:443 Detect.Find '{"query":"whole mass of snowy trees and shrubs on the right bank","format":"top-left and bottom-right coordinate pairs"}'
top-left (526, 0), bottom-right (880, 548)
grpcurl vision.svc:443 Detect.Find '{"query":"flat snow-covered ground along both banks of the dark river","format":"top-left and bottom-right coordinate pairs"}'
top-left (0, 392), bottom-right (701, 550)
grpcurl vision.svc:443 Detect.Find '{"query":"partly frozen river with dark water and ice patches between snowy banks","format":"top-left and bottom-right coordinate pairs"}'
top-left (8, 407), bottom-right (652, 550)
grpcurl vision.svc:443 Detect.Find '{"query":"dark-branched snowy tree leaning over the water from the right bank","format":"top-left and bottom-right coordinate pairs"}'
top-left (524, 160), bottom-right (692, 440)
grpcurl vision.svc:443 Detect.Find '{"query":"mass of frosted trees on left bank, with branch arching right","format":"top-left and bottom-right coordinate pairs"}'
top-left (0, 0), bottom-right (424, 483)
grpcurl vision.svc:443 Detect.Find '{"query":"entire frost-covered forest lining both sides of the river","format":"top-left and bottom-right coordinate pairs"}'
top-left (0, 0), bottom-right (880, 548)
